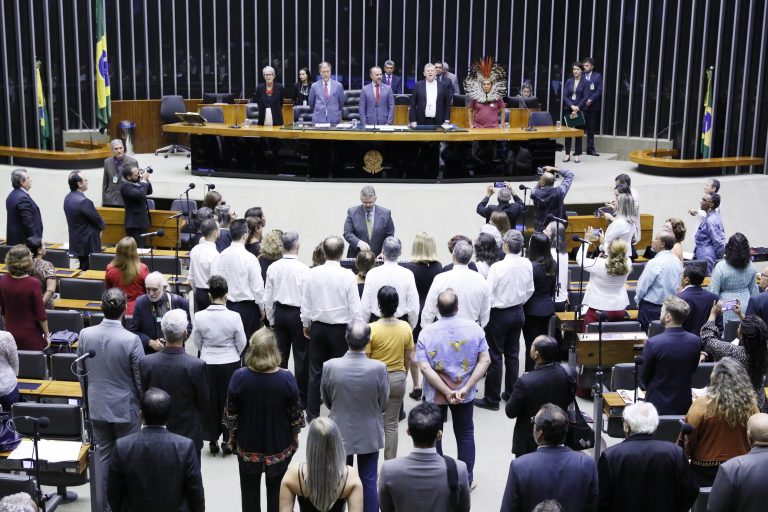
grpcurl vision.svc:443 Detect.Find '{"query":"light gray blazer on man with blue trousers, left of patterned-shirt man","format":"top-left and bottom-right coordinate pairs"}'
top-left (320, 352), bottom-right (389, 455)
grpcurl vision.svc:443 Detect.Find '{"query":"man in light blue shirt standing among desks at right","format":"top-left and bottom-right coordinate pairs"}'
top-left (635, 230), bottom-right (683, 329)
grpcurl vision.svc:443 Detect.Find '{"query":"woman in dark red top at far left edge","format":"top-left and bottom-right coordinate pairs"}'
top-left (0, 245), bottom-right (51, 350)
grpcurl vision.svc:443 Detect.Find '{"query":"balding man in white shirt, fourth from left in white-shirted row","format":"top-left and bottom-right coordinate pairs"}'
top-left (301, 236), bottom-right (360, 422)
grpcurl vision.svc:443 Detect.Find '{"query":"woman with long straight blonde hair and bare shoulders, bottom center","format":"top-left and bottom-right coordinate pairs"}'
top-left (280, 417), bottom-right (363, 512)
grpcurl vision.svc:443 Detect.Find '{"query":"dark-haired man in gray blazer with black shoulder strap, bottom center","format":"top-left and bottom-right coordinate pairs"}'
top-left (379, 402), bottom-right (470, 512)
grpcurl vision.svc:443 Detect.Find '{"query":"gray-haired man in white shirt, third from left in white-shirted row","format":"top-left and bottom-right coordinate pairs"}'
top-left (264, 231), bottom-right (309, 405)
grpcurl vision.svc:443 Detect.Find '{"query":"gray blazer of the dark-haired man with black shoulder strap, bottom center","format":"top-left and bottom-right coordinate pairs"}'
top-left (379, 448), bottom-right (470, 512)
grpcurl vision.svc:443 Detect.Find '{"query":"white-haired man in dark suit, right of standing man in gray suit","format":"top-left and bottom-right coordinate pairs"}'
top-left (140, 309), bottom-right (209, 457)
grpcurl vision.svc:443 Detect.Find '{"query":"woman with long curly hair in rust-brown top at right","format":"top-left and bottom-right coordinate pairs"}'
top-left (685, 357), bottom-right (760, 487)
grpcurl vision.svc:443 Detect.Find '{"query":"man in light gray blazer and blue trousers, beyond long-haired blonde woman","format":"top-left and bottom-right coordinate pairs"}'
top-left (320, 320), bottom-right (389, 512)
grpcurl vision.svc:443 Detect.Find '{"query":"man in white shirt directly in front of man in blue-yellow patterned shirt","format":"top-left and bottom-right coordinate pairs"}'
top-left (421, 241), bottom-right (491, 327)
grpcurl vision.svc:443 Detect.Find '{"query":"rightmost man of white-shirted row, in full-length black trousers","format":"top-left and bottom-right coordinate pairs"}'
top-left (475, 229), bottom-right (533, 411)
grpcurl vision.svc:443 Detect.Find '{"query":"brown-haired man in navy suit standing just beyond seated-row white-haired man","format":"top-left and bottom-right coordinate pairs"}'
top-left (640, 296), bottom-right (701, 414)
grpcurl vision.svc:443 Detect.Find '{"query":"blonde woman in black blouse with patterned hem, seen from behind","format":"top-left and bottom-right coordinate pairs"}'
top-left (224, 327), bottom-right (305, 512)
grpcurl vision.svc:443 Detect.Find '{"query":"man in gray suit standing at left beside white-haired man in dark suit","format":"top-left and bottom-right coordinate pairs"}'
top-left (77, 288), bottom-right (144, 508)
